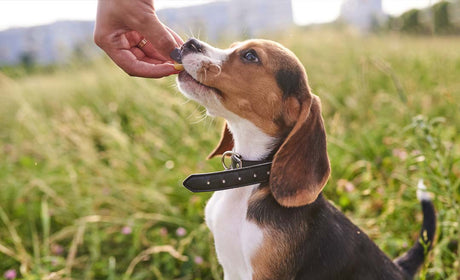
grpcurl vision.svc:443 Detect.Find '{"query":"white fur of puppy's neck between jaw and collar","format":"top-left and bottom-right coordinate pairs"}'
top-left (227, 118), bottom-right (277, 160)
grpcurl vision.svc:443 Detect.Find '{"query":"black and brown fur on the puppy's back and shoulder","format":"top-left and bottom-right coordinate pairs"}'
top-left (247, 191), bottom-right (410, 280)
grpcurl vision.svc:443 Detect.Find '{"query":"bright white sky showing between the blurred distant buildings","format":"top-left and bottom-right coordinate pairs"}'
top-left (0, 0), bottom-right (444, 30)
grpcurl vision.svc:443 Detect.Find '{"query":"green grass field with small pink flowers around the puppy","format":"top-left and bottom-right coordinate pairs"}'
top-left (0, 26), bottom-right (460, 280)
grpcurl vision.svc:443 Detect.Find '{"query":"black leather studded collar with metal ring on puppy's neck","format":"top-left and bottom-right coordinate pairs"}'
top-left (182, 151), bottom-right (272, 192)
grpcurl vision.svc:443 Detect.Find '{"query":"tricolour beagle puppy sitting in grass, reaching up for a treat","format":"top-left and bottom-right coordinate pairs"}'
top-left (176, 39), bottom-right (435, 280)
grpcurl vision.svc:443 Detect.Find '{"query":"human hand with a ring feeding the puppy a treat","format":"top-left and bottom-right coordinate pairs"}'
top-left (94, 0), bottom-right (184, 78)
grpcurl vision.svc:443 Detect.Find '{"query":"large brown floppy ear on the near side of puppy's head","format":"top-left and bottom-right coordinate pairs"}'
top-left (270, 95), bottom-right (330, 207)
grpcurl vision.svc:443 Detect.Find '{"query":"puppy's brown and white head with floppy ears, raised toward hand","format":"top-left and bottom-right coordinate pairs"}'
top-left (178, 39), bottom-right (330, 207)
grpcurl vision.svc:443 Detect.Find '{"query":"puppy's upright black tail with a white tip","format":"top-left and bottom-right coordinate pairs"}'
top-left (394, 180), bottom-right (436, 277)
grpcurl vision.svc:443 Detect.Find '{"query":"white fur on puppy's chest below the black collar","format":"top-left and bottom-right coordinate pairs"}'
top-left (205, 186), bottom-right (263, 280)
